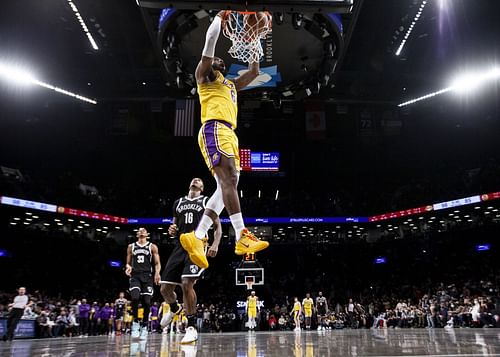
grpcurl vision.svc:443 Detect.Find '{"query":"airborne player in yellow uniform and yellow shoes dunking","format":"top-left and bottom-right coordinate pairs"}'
top-left (180, 12), bottom-right (269, 269)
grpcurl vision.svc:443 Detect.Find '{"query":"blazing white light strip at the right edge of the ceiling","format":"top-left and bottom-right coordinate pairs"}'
top-left (398, 67), bottom-right (500, 108)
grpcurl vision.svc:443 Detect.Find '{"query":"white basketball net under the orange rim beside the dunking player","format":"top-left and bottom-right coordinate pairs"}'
top-left (223, 11), bottom-right (272, 63)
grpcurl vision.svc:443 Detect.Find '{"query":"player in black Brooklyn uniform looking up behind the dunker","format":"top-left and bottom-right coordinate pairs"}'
top-left (160, 178), bottom-right (222, 343)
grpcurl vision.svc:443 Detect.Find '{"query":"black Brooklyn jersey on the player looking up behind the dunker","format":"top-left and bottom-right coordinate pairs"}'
top-left (173, 196), bottom-right (208, 236)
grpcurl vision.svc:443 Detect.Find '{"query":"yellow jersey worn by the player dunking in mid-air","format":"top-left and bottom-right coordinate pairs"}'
top-left (198, 71), bottom-right (238, 129)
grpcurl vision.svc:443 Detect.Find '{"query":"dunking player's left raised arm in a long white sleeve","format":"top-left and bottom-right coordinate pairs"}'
top-left (195, 11), bottom-right (223, 83)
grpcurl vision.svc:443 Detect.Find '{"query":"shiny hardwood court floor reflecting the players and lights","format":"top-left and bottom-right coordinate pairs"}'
top-left (0, 329), bottom-right (500, 357)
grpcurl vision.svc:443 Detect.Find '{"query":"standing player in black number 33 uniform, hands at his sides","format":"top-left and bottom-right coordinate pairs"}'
top-left (125, 228), bottom-right (161, 338)
